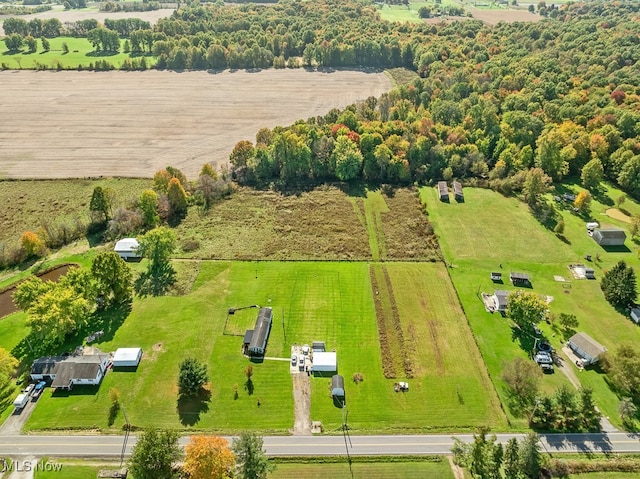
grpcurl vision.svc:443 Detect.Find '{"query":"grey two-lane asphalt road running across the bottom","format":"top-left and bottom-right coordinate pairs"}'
top-left (0, 433), bottom-right (640, 459)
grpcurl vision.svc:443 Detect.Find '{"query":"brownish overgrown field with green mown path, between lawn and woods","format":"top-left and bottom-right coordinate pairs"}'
top-left (176, 187), bottom-right (438, 261)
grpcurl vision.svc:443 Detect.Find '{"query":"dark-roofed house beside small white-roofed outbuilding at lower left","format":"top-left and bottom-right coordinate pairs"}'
top-left (31, 354), bottom-right (109, 390)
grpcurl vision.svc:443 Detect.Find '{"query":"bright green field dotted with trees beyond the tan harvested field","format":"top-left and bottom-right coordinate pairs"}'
top-left (0, 37), bottom-right (156, 69)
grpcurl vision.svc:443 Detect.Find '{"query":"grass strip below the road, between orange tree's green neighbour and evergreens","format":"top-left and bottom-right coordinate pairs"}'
top-left (269, 459), bottom-right (454, 479)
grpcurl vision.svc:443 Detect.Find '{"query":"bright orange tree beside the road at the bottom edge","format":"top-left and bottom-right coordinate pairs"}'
top-left (182, 436), bottom-right (235, 479)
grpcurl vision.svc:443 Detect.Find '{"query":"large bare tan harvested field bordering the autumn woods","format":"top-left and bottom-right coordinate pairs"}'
top-left (0, 69), bottom-right (392, 182)
